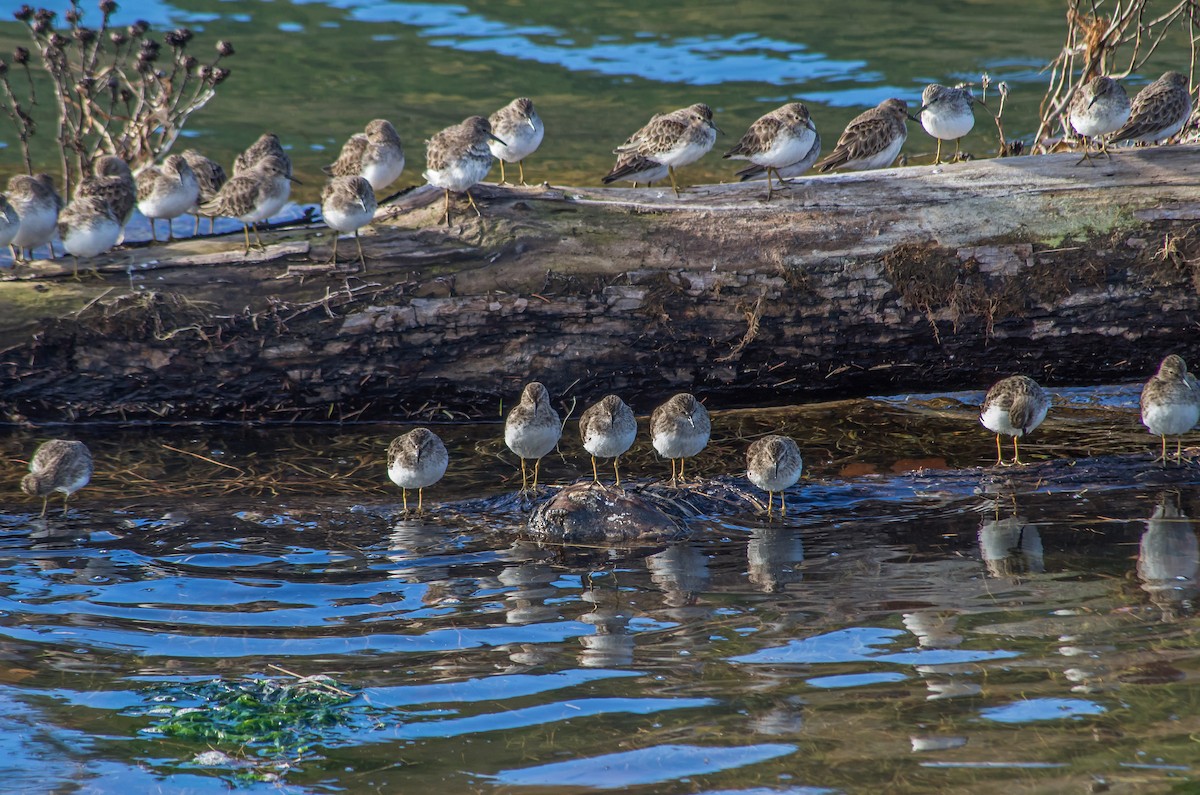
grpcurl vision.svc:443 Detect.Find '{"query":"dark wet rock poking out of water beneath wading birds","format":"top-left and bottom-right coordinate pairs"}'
top-left (528, 482), bottom-right (689, 546)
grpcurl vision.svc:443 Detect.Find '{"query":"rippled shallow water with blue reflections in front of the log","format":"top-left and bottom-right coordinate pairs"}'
top-left (0, 385), bottom-right (1200, 793)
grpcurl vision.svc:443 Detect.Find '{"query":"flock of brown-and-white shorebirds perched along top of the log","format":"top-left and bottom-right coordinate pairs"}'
top-left (0, 72), bottom-right (1192, 271)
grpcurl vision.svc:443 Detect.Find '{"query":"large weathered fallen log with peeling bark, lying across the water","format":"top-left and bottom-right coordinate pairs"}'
top-left (0, 147), bottom-right (1200, 420)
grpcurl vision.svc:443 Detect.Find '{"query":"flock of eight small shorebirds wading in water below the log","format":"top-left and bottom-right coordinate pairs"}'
top-left (20, 354), bottom-right (1200, 516)
